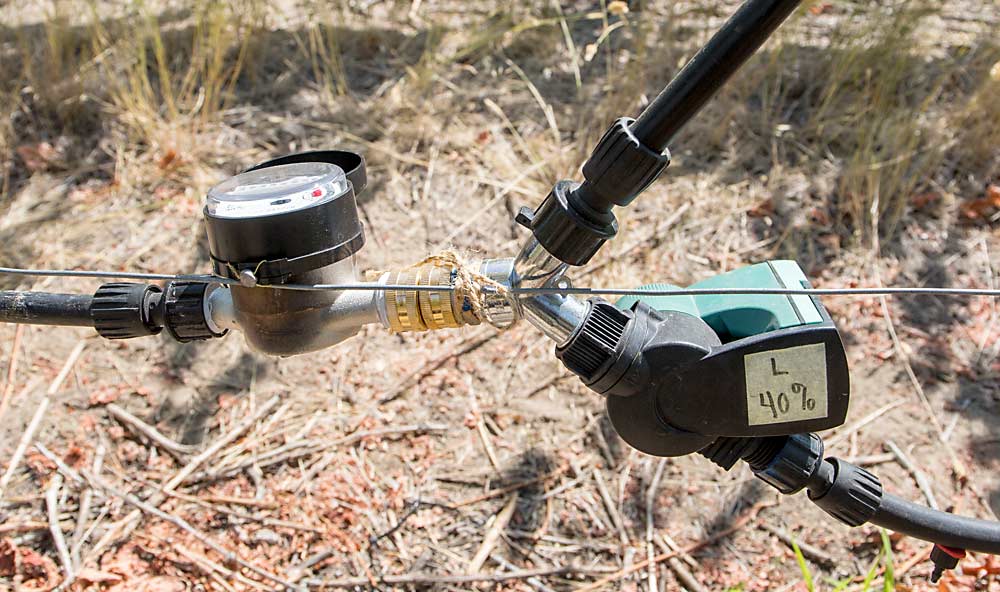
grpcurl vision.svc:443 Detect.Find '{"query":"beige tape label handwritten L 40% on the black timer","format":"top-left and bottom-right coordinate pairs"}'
top-left (743, 343), bottom-right (827, 426)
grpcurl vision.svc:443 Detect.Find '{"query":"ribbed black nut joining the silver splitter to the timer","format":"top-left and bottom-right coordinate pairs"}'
top-left (556, 300), bottom-right (630, 383)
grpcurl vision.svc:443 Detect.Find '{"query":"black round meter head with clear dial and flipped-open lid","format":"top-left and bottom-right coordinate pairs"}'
top-left (204, 150), bottom-right (367, 284)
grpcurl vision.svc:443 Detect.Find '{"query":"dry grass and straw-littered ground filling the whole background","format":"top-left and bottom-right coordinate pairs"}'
top-left (0, 0), bottom-right (1000, 590)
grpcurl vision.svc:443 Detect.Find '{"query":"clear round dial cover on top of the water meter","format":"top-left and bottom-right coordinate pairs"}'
top-left (205, 162), bottom-right (349, 218)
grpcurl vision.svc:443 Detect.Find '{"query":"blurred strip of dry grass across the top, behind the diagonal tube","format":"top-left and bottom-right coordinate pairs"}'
top-left (0, 0), bottom-right (1000, 251)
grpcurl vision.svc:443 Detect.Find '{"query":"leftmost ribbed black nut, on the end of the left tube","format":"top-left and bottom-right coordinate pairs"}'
top-left (90, 283), bottom-right (162, 339)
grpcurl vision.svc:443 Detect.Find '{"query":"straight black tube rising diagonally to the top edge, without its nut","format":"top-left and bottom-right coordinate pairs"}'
top-left (631, 0), bottom-right (800, 152)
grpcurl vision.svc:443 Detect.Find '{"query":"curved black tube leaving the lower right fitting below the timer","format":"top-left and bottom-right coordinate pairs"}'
top-left (868, 493), bottom-right (1000, 555)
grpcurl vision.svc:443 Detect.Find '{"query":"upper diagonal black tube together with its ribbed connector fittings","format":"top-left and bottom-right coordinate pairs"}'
top-left (517, 0), bottom-right (799, 265)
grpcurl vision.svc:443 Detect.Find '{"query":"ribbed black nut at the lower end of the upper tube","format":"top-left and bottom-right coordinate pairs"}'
top-left (583, 117), bottom-right (670, 207)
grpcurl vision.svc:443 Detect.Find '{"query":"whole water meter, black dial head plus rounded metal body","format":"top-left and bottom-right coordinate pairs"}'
top-left (204, 151), bottom-right (378, 355)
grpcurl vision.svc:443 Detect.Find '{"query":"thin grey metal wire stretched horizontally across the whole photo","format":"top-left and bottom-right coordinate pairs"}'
top-left (0, 267), bottom-right (1000, 298)
